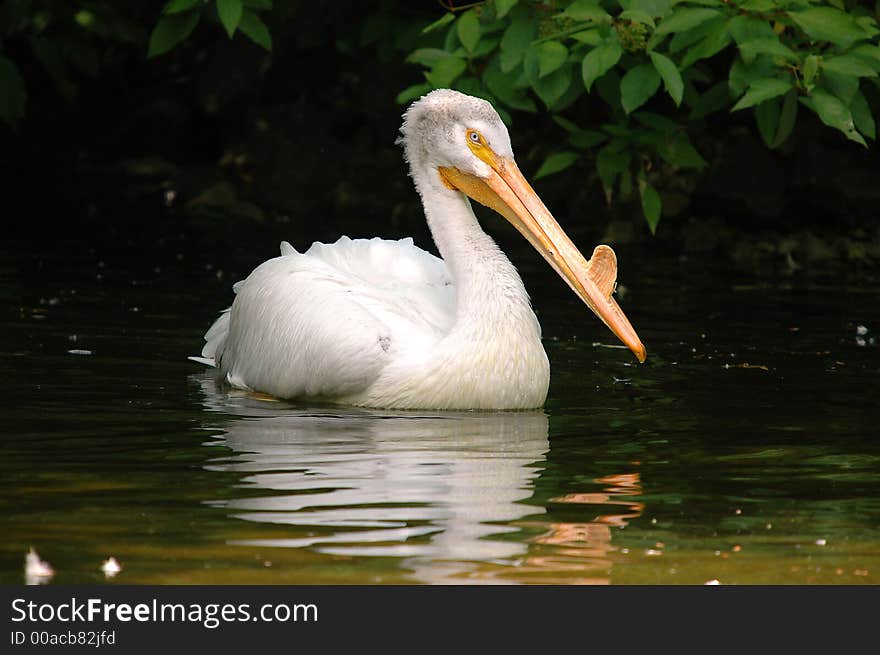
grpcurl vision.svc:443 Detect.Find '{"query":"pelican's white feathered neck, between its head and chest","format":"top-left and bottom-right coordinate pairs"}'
top-left (413, 171), bottom-right (537, 333)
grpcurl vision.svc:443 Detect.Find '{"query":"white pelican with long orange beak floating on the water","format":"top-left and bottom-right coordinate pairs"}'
top-left (194, 89), bottom-right (646, 409)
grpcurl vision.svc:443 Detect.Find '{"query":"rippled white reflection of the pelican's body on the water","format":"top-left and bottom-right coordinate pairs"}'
top-left (196, 377), bottom-right (549, 582)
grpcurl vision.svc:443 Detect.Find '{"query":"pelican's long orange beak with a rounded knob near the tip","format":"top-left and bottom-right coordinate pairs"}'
top-left (438, 151), bottom-right (647, 362)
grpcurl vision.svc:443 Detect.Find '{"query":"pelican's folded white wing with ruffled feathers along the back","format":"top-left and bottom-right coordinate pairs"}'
top-left (202, 237), bottom-right (455, 398)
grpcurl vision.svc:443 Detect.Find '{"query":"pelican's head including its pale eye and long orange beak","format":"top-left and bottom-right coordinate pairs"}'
top-left (400, 89), bottom-right (646, 362)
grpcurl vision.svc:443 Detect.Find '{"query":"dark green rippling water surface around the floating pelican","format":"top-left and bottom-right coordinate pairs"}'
top-left (0, 229), bottom-right (880, 584)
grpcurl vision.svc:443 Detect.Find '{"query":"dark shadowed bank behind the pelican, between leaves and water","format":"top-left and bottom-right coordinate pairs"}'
top-left (0, 1), bottom-right (880, 282)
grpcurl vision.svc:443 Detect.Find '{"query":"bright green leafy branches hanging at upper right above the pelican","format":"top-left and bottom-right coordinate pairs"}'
top-left (398, 0), bottom-right (880, 231)
